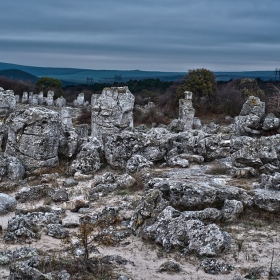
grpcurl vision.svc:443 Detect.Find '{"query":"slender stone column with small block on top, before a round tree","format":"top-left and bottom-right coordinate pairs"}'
top-left (179, 91), bottom-right (195, 131)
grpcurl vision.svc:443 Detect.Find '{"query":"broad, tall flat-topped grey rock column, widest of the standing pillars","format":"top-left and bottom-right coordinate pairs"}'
top-left (91, 87), bottom-right (135, 141)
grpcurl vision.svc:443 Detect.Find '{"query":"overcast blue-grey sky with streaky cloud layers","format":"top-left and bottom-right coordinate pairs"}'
top-left (0, 0), bottom-right (280, 72)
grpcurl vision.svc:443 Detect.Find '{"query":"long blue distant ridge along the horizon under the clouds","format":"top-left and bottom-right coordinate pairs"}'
top-left (0, 62), bottom-right (274, 85)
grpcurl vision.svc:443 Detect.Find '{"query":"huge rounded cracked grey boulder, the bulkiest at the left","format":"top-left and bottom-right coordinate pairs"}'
top-left (6, 107), bottom-right (60, 170)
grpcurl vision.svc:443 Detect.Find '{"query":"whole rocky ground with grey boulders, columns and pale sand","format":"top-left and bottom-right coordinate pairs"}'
top-left (0, 87), bottom-right (280, 280)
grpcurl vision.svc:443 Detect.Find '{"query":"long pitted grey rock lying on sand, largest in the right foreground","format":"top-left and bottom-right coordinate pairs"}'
top-left (142, 206), bottom-right (231, 257)
